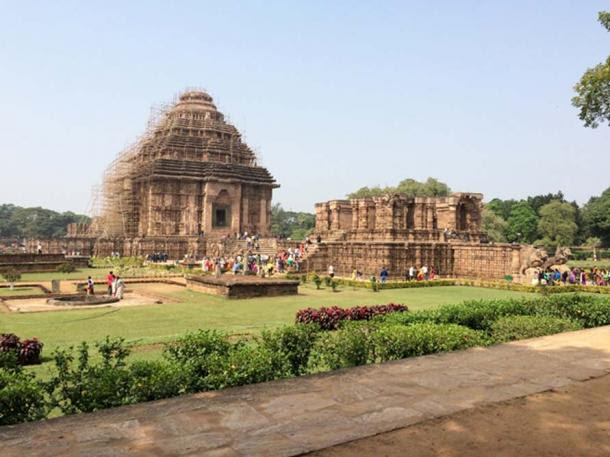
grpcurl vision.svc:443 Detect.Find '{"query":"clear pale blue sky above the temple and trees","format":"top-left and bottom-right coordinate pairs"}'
top-left (0, 0), bottom-right (610, 212)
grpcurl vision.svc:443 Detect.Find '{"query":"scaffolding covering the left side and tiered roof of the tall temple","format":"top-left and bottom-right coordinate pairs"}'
top-left (90, 88), bottom-right (260, 238)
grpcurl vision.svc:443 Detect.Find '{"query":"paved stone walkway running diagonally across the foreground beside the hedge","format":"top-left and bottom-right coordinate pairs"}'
top-left (0, 326), bottom-right (610, 457)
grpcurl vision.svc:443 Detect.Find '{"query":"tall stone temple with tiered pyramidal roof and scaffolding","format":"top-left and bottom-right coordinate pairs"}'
top-left (55, 90), bottom-right (279, 258)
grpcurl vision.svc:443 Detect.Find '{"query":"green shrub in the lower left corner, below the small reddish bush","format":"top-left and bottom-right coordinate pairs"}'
top-left (0, 366), bottom-right (48, 425)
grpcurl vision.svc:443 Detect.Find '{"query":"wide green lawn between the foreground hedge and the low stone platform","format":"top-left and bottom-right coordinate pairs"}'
top-left (0, 285), bottom-right (527, 355)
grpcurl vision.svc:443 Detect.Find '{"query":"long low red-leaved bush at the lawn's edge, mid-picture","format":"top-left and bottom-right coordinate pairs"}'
top-left (296, 303), bottom-right (408, 330)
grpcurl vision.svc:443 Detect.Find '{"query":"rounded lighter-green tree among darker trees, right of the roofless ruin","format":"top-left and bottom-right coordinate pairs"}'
top-left (538, 200), bottom-right (578, 246)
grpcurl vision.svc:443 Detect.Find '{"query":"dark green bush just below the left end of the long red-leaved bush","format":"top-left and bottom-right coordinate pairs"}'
top-left (261, 324), bottom-right (320, 376)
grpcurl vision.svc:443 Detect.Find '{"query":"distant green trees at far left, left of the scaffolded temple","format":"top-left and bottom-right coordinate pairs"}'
top-left (0, 204), bottom-right (90, 238)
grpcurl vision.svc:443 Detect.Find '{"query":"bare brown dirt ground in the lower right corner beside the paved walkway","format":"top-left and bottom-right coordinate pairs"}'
top-left (308, 375), bottom-right (610, 457)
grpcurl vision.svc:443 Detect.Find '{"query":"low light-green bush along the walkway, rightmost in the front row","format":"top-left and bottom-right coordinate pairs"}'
top-left (491, 316), bottom-right (582, 343)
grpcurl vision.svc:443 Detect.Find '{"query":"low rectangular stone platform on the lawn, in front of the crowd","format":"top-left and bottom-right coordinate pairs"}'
top-left (186, 275), bottom-right (299, 298)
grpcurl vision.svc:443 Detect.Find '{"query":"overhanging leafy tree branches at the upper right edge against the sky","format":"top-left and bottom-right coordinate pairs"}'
top-left (572, 11), bottom-right (610, 128)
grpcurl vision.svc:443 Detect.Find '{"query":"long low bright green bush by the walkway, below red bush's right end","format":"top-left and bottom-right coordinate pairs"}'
top-left (372, 323), bottom-right (486, 362)
